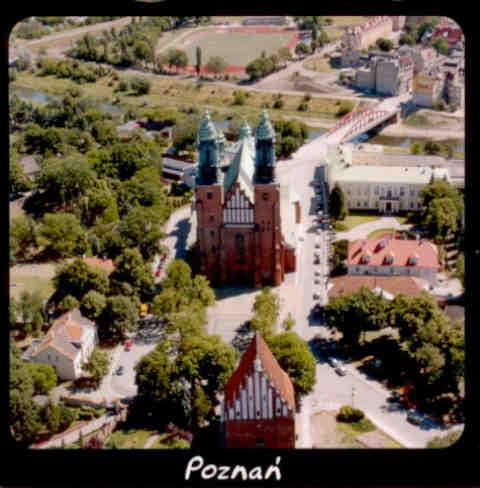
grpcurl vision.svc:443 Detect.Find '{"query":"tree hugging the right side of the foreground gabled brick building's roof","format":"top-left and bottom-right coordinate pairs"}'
top-left (268, 332), bottom-right (316, 399)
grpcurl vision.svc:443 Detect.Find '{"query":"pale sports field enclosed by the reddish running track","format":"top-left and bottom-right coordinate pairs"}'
top-left (182, 32), bottom-right (293, 66)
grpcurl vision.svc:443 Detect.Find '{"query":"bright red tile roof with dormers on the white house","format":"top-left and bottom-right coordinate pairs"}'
top-left (347, 236), bottom-right (439, 269)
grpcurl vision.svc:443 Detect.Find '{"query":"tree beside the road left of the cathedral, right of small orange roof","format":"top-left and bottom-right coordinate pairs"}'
top-left (110, 248), bottom-right (153, 301)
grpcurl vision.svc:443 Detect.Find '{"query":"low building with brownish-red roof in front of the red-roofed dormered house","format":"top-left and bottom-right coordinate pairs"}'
top-left (328, 275), bottom-right (429, 300)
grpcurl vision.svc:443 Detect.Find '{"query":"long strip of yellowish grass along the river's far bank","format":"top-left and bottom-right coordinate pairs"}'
top-left (11, 71), bottom-right (354, 120)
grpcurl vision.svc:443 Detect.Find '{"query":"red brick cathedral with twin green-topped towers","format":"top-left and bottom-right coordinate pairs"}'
top-left (195, 111), bottom-right (300, 287)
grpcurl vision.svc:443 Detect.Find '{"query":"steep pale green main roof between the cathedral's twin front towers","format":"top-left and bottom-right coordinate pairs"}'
top-left (223, 132), bottom-right (255, 203)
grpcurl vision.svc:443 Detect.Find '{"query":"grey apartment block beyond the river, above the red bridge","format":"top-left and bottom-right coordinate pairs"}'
top-left (354, 55), bottom-right (414, 96)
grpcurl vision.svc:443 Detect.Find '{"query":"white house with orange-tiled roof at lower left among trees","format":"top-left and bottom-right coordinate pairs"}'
top-left (23, 308), bottom-right (98, 380)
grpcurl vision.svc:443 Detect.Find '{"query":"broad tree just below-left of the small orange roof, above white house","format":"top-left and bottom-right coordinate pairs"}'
top-left (53, 258), bottom-right (109, 302)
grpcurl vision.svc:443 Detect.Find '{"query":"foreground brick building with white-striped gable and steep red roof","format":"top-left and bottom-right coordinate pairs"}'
top-left (222, 332), bottom-right (295, 449)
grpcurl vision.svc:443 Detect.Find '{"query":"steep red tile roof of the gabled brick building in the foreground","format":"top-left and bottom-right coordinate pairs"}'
top-left (225, 332), bottom-right (295, 409)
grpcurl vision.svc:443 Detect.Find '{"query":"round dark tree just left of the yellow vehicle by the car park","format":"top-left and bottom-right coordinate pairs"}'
top-left (97, 295), bottom-right (138, 342)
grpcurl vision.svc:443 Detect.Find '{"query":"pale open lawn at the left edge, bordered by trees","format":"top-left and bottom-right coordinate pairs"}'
top-left (10, 263), bottom-right (55, 299)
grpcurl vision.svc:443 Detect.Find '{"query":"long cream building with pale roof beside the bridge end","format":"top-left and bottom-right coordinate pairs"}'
top-left (327, 146), bottom-right (450, 214)
